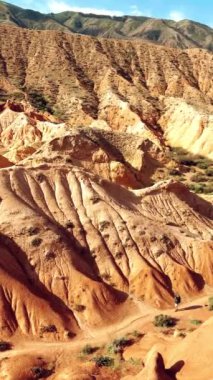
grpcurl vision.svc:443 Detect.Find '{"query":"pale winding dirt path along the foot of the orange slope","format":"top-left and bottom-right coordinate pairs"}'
top-left (0, 296), bottom-right (210, 359)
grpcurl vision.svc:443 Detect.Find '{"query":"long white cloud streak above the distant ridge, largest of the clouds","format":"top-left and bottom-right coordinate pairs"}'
top-left (48, 0), bottom-right (123, 16)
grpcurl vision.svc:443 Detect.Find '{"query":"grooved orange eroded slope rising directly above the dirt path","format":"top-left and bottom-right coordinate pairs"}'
top-left (0, 163), bottom-right (213, 339)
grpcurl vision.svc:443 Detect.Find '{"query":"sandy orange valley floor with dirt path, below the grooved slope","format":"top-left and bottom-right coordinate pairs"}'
top-left (0, 288), bottom-right (213, 380)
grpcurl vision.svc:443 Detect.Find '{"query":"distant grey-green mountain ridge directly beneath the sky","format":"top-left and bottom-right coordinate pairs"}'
top-left (0, 1), bottom-right (213, 51)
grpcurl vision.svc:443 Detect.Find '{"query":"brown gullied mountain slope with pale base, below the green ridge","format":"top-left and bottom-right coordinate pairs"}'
top-left (0, 25), bottom-right (213, 158)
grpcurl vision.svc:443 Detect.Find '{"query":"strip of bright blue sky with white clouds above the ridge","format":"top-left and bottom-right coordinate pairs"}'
top-left (8, 0), bottom-right (213, 27)
